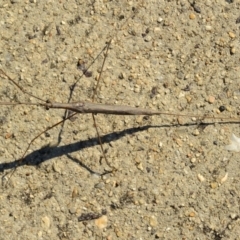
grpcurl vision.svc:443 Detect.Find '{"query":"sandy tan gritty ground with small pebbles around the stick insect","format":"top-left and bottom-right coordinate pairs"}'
top-left (0, 0), bottom-right (240, 240)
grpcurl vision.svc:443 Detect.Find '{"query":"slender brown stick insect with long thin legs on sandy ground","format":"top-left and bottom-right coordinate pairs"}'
top-left (0, 14), bottom-right (240, 186)
